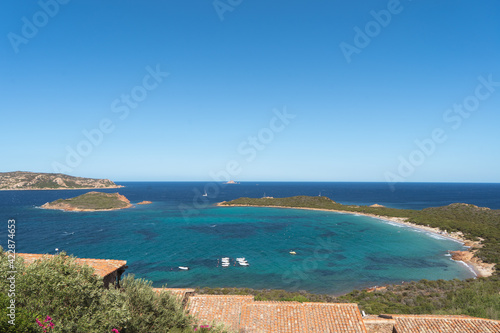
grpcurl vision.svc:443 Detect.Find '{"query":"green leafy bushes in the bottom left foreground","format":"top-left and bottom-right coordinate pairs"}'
top-left (0, 253), bottom-right (230, 333)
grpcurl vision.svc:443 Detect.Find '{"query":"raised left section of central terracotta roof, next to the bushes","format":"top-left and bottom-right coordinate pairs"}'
top-left (187, 295), bottom-right (253, 330)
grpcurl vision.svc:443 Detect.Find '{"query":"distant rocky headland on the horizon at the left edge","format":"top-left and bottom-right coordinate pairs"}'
top-left (0, 171), bottom-right (123, 190)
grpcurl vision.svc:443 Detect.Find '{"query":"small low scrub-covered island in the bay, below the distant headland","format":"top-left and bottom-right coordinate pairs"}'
top-left (41, 192), bottom-right (133, 212)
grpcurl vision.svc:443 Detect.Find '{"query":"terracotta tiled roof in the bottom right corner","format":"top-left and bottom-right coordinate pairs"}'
top-left (389, 315), bottom-right (500, 333)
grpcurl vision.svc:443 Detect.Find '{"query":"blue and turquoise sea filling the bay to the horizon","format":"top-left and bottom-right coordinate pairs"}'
top-left (0, 182), bottom-right (500, 294)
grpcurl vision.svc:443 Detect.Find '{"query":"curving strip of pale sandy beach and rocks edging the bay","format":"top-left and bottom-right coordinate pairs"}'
top-left (215, 201), bottom-right (495, 277)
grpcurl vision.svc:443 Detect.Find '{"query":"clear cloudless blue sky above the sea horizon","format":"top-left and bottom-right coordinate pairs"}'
top-left (0, 0), bottom-right (500, 182)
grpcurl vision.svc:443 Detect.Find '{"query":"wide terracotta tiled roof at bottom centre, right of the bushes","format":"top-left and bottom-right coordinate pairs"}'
top-left (187, 295), bottom-right (366, 333)
